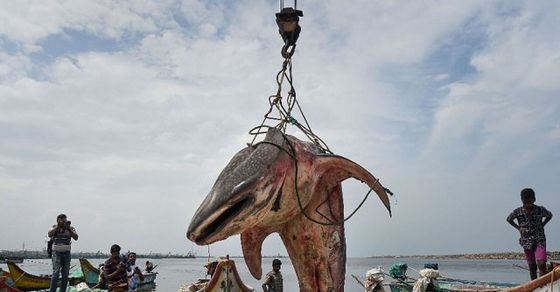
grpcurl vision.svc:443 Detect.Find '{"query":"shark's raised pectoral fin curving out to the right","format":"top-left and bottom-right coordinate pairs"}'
top-left (316, 155), bottom-right (391, 216)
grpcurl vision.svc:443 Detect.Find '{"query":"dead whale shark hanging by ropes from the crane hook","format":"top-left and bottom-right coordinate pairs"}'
top-left (187, 128), bottom-right (391, 292)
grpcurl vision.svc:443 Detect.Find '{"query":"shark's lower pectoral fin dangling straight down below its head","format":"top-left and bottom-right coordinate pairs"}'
top-left (241, 227), bottom-right (273, 280)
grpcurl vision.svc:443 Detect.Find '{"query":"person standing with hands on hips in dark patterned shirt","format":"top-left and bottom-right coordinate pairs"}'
top-left (506, 188), bottom-right (552, 280)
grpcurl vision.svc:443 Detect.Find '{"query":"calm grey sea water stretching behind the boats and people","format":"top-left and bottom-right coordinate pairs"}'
top-left (0, 257), bottom-right (529, 292)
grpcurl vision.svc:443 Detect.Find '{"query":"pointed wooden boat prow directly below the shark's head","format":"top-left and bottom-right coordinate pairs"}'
top-left (179, 257), bottom-right (255, 292)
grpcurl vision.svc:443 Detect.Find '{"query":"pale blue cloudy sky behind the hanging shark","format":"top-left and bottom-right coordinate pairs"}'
top-left (0, 0), bottom-right (560, 257)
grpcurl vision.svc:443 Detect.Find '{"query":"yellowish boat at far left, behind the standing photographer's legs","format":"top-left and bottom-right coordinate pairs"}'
top-left (6, 261), bottom-right (82, 290)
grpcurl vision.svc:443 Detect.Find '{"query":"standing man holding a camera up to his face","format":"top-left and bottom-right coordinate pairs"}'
top-left (47, 214), bottom-right (78, 292)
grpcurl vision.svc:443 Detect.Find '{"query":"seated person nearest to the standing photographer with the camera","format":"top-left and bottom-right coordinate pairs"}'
top-left (103, 244), bottom-right (128, 292)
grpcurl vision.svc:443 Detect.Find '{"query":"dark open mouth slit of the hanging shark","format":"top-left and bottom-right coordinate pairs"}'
top-left (195, 194), bottom-right (255, 244)
